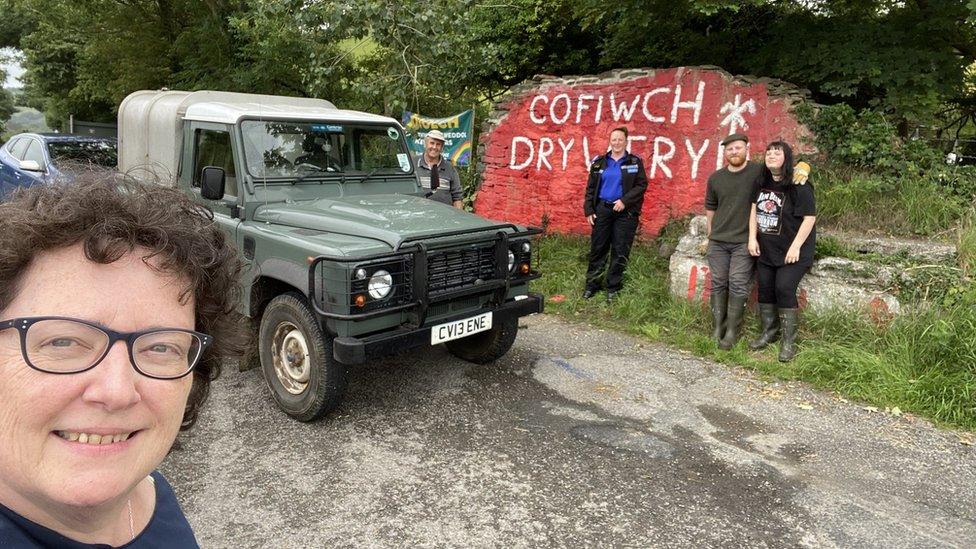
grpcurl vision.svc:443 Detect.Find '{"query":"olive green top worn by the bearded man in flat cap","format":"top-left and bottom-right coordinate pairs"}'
top-left (705, 162), bottom-right (762, 244)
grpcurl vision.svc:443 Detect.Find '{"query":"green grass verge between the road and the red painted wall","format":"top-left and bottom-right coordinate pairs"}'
top-left (534, 236), bottom-right (976, 430)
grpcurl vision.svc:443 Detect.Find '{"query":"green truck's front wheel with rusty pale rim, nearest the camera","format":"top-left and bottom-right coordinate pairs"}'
top-left (258, 293), bottom-right (348, 421)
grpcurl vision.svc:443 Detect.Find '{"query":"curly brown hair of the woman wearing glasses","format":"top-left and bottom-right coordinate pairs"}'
top-left (0, 173), bottom-right (246, 430)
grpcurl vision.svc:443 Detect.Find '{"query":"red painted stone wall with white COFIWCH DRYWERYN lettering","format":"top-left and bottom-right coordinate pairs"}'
top-left (475, 67), bottom-right (812, 236)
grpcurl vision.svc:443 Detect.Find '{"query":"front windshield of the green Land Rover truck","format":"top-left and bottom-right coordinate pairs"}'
top-left (241, 120), bottom-right (412, 178)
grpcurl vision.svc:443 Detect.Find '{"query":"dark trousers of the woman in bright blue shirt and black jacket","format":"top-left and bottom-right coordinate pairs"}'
top-left (586, 200), bottom-right (640, 292)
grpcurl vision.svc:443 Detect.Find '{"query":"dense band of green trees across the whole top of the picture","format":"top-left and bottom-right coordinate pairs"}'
top-left (0, 0), bottom-right (976, 128)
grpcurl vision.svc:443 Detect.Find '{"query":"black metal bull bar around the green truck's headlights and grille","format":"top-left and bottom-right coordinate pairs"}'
top-left (308, 223), bottom-right (543, 326)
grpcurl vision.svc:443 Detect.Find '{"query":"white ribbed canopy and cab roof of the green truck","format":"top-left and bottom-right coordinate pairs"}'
top-left (119, 90), bottom-right (397, 185)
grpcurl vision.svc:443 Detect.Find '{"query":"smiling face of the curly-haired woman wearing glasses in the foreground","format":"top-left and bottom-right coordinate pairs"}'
top-left (0, 246), bottom-right (194, 518)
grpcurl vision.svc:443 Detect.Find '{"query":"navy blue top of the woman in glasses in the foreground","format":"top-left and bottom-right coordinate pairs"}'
top-left (0, 471), bottom-right (200, 549)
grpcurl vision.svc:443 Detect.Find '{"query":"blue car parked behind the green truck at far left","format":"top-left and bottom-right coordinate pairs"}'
top-left (0, 133), bottom-right (118, 197)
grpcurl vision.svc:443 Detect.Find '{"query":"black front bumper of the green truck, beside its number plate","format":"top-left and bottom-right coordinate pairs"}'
top-left (332, 292), bottom-right (544, 364)
